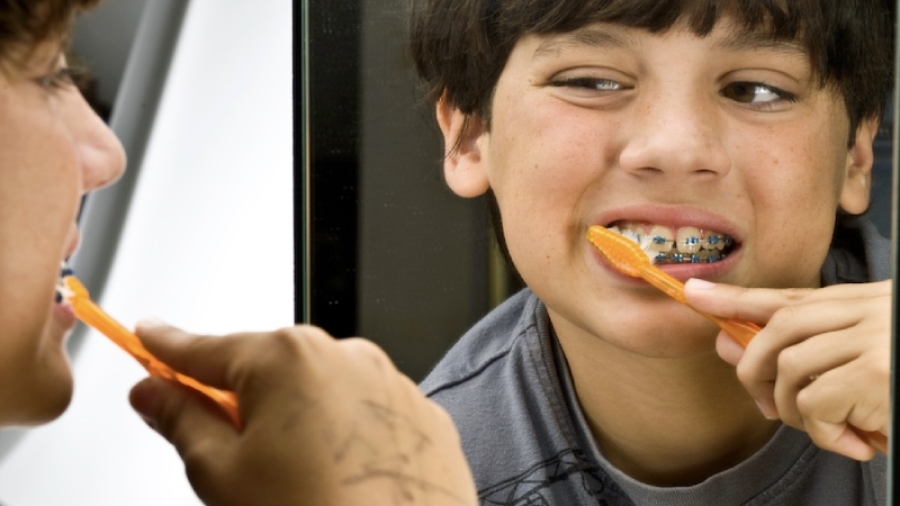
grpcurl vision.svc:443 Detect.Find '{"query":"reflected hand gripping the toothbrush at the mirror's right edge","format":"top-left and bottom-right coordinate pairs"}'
top-left (685, 280), bottom-right (892, 460)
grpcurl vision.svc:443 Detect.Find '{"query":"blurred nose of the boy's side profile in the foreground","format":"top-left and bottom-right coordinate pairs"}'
top-left (68, 90), bottom-right (126, 193)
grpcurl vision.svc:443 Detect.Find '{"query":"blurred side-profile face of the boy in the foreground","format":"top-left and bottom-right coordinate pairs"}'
top-left (0, 40), bottom-right (125, 426)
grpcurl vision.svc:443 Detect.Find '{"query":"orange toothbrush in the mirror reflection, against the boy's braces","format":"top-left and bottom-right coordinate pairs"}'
top-left (587, 225), bottom-right (888, 453)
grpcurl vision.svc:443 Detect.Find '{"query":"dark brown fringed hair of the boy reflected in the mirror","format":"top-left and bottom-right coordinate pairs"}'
top-left (409, 0), bottom-right (896, 143)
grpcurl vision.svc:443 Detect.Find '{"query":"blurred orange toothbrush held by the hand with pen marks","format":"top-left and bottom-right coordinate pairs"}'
top-left (59, 271), bottom-right (241, 428)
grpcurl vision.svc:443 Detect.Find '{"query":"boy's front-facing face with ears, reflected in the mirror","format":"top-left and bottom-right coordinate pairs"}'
top-left (438, 22), bottom-right (876, 356)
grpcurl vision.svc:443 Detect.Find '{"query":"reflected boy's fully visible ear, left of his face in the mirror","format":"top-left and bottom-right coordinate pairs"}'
top-left (436, 97), bottom-right (490, 197)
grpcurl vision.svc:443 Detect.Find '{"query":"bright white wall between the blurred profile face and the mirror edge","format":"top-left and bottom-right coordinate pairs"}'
top-left (0, 0), bottom-right (294, 506)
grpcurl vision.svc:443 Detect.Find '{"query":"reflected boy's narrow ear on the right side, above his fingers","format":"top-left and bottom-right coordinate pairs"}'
top-left (839, 117), bottom-right (879, 214)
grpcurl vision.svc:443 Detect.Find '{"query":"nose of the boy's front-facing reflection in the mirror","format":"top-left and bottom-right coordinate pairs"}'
top-left (619, 89), bottom-right (731, 179)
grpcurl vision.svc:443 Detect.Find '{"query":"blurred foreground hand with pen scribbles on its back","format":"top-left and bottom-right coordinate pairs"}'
top-left (131, 323), bottom-right (477, 506)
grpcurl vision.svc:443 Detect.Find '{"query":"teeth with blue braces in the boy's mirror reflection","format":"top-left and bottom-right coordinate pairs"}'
top-left (607, 220), bottom-right (738, 265)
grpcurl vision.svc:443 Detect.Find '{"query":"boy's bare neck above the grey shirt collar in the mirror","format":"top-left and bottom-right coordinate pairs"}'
top-left (560, 318), bottom-right (779, 486)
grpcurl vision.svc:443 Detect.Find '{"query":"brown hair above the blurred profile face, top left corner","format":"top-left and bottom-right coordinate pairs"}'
top-left (0, 0), bottom-right (102, 65)
